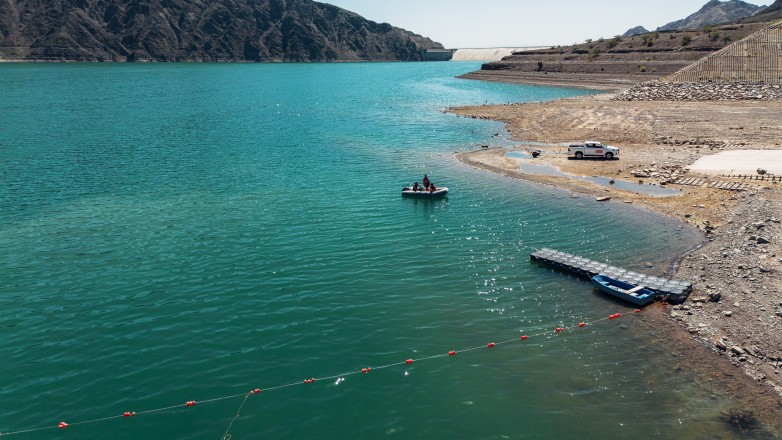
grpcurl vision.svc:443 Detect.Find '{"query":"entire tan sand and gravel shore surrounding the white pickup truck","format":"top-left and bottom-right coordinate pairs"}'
top-left (449, 92), bottom-right (782, 425)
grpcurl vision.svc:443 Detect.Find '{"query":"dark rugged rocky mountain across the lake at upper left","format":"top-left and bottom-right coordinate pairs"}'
top-left (0, 0), bottom-right (443, 61)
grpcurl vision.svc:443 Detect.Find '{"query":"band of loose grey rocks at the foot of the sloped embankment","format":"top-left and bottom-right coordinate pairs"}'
top-left (614, 81), bottom-right (782, 101)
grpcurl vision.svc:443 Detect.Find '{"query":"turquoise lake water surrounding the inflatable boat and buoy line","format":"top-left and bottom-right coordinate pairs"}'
top-left (0, 63), bottom-right (772, 439)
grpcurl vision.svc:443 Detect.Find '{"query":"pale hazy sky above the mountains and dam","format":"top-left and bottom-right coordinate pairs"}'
top-left (319, 0), bottom-right (774, 49)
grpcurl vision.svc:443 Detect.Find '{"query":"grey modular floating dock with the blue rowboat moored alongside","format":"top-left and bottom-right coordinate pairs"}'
top-left (529, 248), bottom-right (692, 303)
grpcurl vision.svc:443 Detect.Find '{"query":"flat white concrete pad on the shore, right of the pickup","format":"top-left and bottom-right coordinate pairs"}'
top-left (688, 150), bottom-right (782, 175)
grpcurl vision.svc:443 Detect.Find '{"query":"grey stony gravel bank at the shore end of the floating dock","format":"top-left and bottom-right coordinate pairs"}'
top-left (670, 191), bottom-right (782, 396)
